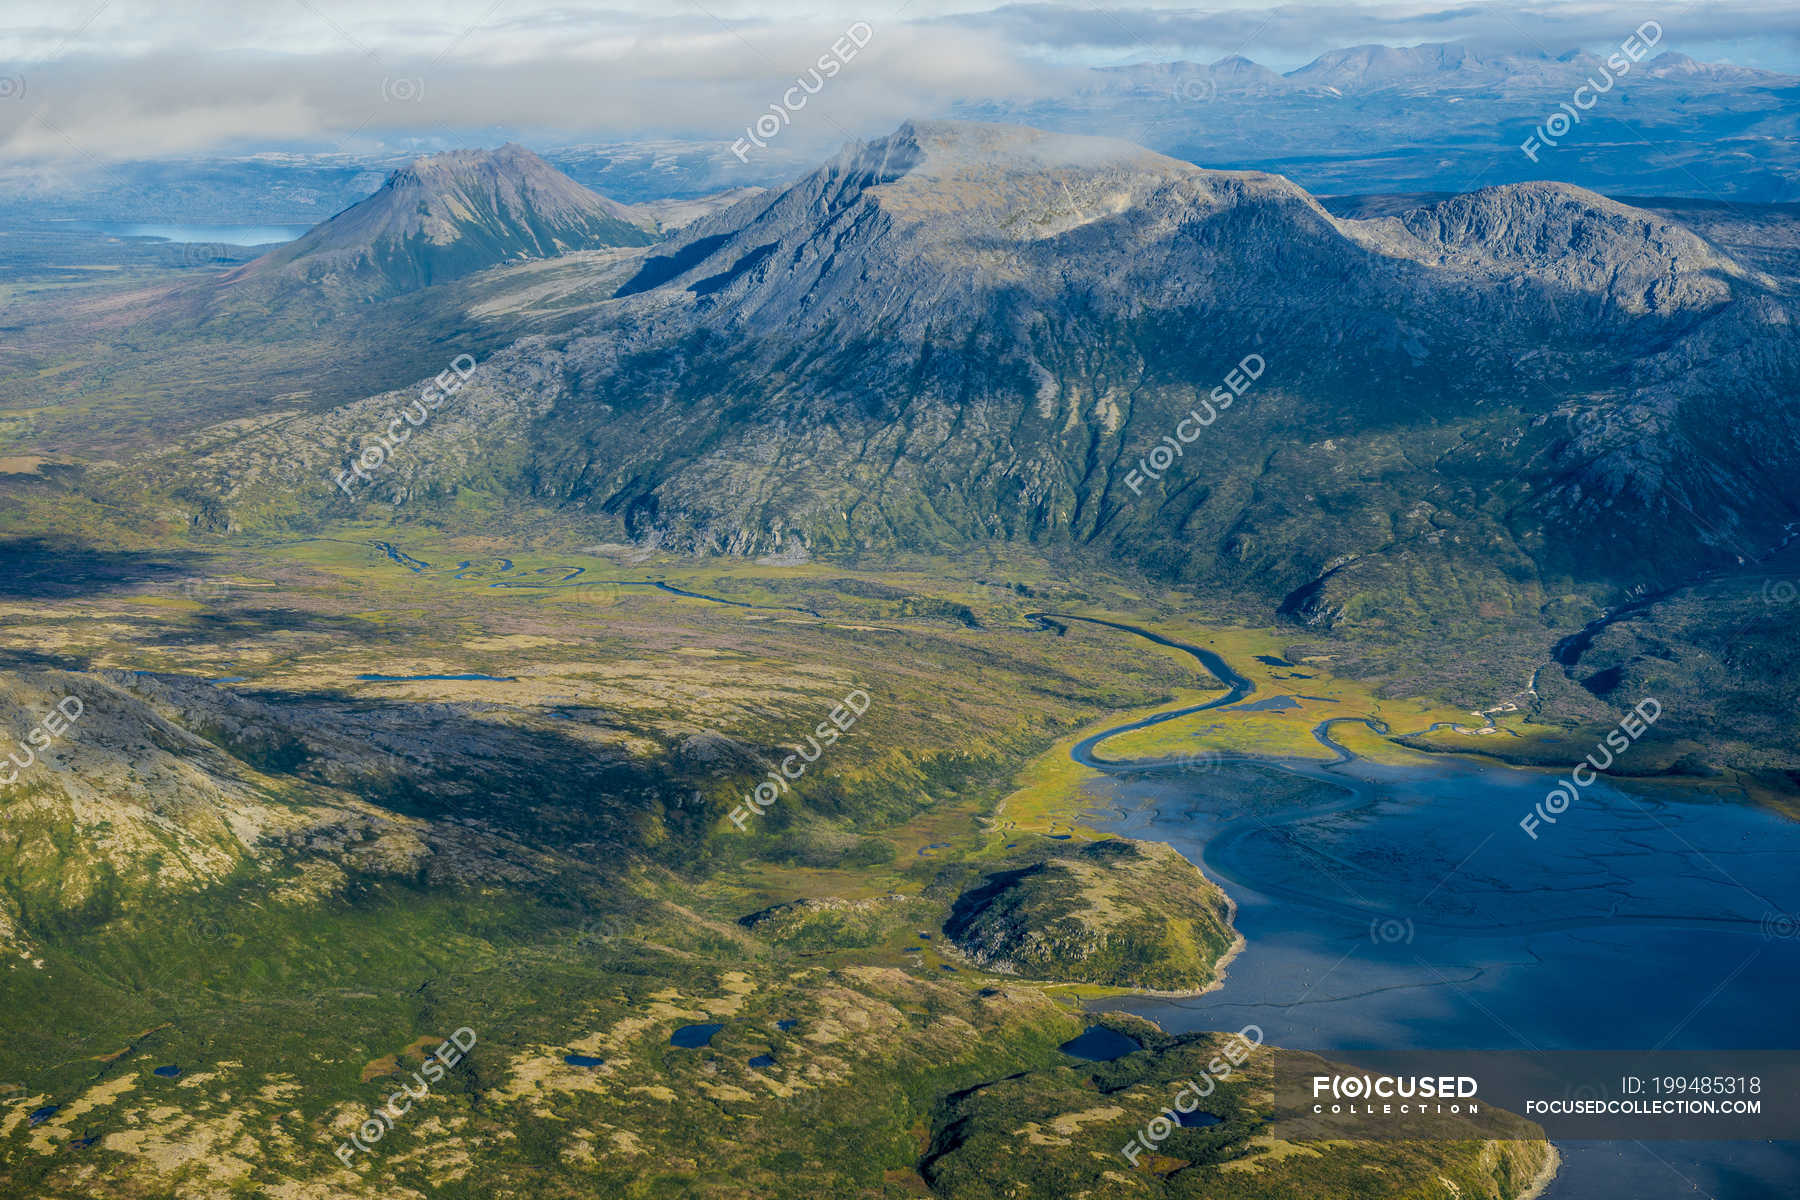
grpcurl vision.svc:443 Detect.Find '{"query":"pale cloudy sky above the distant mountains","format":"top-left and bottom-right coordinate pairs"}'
top-left (0, 0), bottom-right (1800, 160)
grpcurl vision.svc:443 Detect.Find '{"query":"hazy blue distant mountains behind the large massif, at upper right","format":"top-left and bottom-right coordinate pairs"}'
top-left (952, 43), bottom-right (1800, 203)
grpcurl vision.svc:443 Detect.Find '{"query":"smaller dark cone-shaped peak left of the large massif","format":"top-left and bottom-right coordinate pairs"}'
top-left (225, 144), bottom-right (653, 291)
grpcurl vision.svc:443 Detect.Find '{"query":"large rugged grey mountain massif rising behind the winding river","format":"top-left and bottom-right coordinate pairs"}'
top-left (154, 122), bottom-right (1800, 651)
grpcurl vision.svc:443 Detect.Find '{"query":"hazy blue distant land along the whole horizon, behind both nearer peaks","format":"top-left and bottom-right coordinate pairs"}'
top-left (0, 39), bottom-right (1800, 228)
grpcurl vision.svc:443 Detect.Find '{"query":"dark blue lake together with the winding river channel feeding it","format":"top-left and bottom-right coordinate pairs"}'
top-left (1031, 613), bottom-right (1800, 1200)
